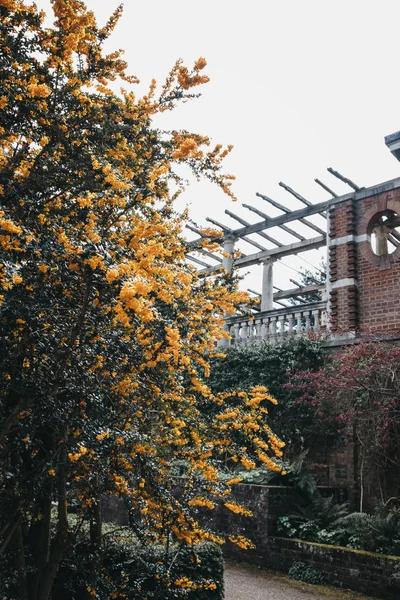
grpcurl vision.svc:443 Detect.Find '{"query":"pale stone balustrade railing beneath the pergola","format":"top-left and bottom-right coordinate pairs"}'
top-left (226, 302), bottom-right (326, 346)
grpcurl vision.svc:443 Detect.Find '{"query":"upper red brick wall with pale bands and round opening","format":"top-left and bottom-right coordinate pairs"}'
top-left (329, 189), bottom-right (400, 338)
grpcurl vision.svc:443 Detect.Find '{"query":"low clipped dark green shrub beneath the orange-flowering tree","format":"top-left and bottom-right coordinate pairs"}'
top-left (54, 528), bottom-right (224, 600)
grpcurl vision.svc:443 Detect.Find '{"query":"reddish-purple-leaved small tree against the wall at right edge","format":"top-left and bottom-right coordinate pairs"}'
top-left (302, 342), bottom-right (400, 512)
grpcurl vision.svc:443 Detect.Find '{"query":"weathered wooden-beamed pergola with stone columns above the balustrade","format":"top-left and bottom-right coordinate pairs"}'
top-left (187, 168), bottom-right (364, 311)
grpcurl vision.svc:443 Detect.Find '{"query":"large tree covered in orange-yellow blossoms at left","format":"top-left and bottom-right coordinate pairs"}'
top-left (0, 0), bottom-right (282, 600)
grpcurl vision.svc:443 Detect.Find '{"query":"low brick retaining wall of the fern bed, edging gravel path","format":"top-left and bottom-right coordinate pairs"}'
top-left (226, 537), bottom-right (400, 600)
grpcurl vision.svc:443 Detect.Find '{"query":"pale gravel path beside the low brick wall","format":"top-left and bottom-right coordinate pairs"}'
top-left (225, 561), bottom-right (372, 600)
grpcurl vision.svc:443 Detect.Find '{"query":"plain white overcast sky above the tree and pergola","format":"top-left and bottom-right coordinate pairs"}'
top-left (37, 0), bottom-right (400, 296)
